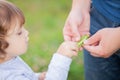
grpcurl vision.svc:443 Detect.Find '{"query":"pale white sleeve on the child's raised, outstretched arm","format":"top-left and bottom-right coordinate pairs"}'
top-left (45, 53), bottom-right (72, 80)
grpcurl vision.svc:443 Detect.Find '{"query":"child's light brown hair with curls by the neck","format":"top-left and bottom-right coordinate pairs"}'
top-left (0, 0), bottom-right (25, 59)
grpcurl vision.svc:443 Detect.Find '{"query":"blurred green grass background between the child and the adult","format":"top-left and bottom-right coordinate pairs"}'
top-left (8, 0), bottom-right (84, 80)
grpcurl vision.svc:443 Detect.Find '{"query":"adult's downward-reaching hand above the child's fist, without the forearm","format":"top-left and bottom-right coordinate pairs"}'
top-left (63, 11), bottom-right (90, 41)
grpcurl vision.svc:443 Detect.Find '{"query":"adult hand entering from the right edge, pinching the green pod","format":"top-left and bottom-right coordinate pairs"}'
top-left (84, 28), bottom-right (120, 58)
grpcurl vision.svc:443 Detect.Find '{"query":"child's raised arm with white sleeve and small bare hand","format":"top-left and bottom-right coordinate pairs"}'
top-left (45, 42), bottom-right (78, 80)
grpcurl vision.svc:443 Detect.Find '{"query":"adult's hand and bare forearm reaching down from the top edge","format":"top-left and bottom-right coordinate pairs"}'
top-left (63, 0), bottom-right (90, 41)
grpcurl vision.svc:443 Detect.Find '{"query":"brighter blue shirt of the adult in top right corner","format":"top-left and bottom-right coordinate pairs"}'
top-left (92, 0), bottom-right (120, 22)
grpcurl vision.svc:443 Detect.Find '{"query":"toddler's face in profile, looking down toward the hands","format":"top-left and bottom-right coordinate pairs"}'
top-left (5, 22), bottom-right (29, 58)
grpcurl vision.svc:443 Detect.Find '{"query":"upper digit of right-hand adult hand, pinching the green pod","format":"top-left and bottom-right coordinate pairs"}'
top-left (84, 32), bottom-right (101, 45)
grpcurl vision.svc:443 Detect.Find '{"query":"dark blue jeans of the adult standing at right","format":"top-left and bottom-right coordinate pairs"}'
top-left (84, 4), bottom-right (120, 80)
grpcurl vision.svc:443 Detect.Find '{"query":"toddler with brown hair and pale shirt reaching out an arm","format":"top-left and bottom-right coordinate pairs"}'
top-left (0, 0), bottom-right (78, 80)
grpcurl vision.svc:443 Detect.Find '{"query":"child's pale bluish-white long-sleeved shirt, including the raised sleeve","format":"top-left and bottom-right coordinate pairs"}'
top-left (0, 54), bottom-right (72, 80)
